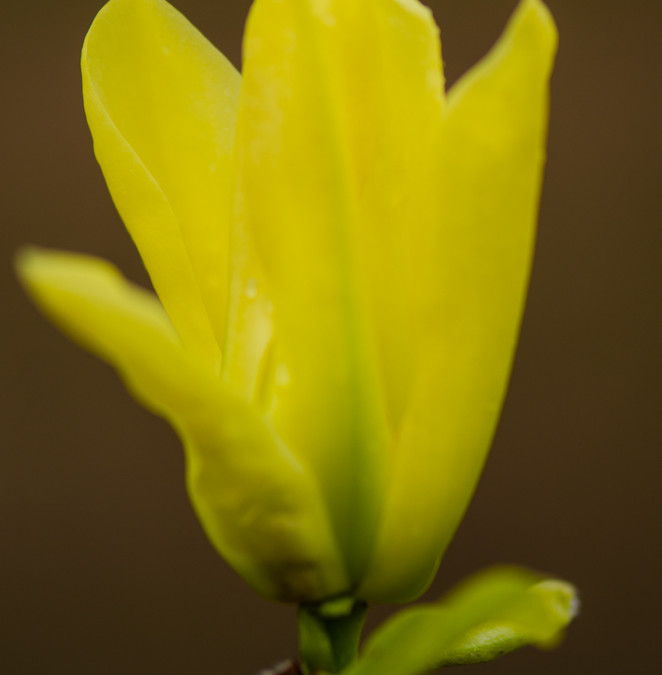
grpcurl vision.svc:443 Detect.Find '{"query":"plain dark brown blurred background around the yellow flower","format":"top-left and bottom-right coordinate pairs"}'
top-left (0, 0), bottom-right (662, 675)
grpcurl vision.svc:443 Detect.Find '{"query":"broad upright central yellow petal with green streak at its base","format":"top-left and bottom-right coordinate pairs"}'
top-left (237, 0), bottom-right (442, 576)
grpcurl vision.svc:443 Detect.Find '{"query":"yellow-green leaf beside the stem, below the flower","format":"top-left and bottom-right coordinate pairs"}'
top-left (344, 567), bottom-right (577, 675)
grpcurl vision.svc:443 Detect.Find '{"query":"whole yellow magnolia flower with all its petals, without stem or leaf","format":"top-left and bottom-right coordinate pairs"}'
top-left (19, 0), bottom-right (556, 602)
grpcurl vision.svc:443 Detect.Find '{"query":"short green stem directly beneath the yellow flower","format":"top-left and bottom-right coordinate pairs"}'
top-left (298, 598), bottom-right (367, 675)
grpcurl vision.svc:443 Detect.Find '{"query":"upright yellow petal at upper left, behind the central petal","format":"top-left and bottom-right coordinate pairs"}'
top-left (82, 0), bottom-right (240, 366)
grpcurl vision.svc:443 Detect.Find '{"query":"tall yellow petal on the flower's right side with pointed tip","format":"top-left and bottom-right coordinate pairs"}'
top-left (362, 0), bottom-right (557, 600)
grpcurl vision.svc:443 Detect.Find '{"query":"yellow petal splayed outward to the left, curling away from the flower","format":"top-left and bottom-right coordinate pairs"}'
top-left (18, 250), bottom-right (347, 601)
